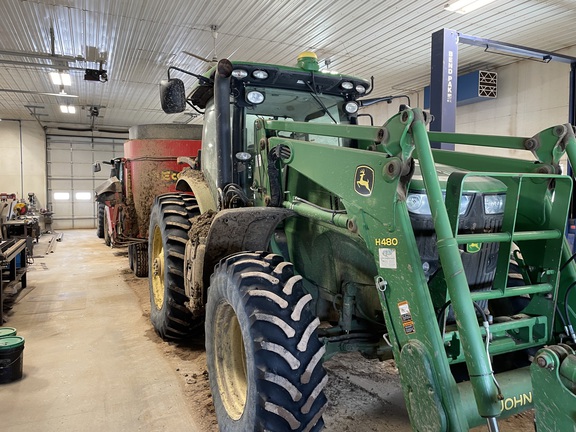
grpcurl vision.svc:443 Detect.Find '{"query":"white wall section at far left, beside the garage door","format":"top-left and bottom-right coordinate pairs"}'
top-left (0, 119), bottom-right (47, 207)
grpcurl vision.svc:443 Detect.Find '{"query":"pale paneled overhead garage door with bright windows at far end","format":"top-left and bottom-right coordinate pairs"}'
top-left (46, 135), bottom-right (124, 230)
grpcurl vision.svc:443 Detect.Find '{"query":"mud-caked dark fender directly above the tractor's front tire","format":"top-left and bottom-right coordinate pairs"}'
top-left (184, 207), bottom-right (296, 316)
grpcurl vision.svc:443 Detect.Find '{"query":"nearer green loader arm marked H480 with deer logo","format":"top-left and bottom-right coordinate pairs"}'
top-left (260, 111), bottom-right (472, 431)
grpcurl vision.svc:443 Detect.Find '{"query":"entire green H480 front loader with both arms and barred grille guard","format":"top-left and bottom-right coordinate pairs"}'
top-left (256, 109), bottom-right (576, 431)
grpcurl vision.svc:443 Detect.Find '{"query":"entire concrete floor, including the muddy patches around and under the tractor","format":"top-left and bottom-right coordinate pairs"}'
top-left (0, 230), bottom-right (533, 432)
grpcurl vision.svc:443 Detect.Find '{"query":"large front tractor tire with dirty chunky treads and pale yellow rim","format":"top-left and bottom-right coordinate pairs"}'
top-left (205, 252), bottom-right (328, 432)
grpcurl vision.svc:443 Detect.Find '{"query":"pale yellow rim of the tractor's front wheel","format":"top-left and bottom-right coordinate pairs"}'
top-left (212, 303), bottom-right (248, 420)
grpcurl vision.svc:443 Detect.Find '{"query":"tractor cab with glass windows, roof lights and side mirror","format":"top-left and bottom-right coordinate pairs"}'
top-left (161, 52), bottom-right (371, 208)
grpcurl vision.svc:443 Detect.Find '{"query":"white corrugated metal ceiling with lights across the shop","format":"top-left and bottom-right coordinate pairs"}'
top-left (0, 0), bottom-right (576, 129)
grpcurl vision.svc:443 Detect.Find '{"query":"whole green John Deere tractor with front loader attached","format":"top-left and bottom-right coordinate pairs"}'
top-left (149, 53), bottom-right (576, 432)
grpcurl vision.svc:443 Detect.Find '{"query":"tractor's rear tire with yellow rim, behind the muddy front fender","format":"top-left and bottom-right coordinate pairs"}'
top-left (148, 193), bottom-right (201, 340)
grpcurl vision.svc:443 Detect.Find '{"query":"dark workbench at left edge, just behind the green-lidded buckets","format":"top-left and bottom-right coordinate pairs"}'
top-left (0, 239), bottom-right (27, 325)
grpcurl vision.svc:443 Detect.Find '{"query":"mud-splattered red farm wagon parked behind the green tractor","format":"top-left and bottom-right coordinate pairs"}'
top-left (94, 124), bottom-right (202, 277)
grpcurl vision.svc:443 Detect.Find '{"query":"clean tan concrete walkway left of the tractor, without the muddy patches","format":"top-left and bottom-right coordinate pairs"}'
top-left (0, 230), bottom-right (201, 432)
